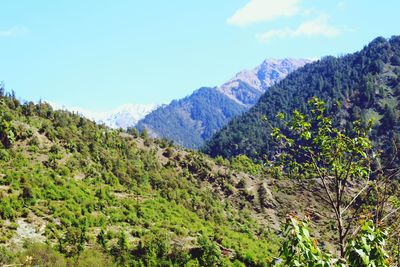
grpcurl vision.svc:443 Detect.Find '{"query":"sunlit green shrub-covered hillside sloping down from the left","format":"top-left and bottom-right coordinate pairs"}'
top-left (0, 89), bottom-right (284, 266)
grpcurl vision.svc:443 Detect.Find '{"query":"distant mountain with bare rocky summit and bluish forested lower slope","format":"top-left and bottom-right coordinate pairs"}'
top-left (137, 59), bottom-right (310, 148)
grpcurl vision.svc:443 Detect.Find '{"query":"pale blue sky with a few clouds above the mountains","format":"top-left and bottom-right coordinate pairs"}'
top-left (0, 0), bottom-right (400, 110)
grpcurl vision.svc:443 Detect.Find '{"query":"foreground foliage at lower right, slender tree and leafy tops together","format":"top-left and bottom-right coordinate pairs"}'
top-left (273, 98), bottom-right (398, 267)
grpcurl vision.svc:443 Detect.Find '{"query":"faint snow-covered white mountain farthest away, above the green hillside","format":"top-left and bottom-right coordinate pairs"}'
top-left (52, 103), bottom-right (156, 129)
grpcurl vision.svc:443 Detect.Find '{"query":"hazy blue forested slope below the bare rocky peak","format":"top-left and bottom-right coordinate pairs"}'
top-left (137, 87), bottom-right (247, 148)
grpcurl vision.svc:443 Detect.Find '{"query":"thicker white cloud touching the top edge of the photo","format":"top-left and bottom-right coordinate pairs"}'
top-left (227, 0), bottom-right (300, 26)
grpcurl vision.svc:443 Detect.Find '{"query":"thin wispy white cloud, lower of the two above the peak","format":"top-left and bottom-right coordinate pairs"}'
top-left (256, 15), bottom-right (341, 43)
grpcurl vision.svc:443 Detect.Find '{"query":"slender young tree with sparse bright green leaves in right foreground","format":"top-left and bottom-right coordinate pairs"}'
top-left (272, 98), bottom-right (374, 257)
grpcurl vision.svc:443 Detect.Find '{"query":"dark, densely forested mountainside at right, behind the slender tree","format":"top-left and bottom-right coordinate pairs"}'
top-left (203, 36), bottom-right (400, 159)
